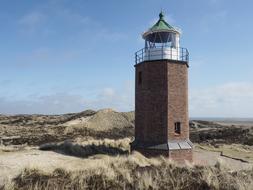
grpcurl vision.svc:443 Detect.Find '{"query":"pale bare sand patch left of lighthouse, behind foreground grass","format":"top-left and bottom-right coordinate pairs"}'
top-left (0, 149), bottom-right (96, 185)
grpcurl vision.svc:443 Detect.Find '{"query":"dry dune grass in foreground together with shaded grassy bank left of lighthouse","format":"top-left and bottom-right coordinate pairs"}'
top-left (0, 138), bottom-right (253, 190)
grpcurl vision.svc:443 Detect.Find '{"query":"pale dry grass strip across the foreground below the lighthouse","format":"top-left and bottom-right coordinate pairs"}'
top-left (3, 153), bottom-right (253, 190)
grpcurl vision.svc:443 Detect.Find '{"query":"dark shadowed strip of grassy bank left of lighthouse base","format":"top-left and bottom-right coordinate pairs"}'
top-left (39, 141), bottom-right (129, 158)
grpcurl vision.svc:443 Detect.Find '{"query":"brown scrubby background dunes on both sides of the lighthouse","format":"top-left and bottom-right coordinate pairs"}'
top-left (0, 109), bottom-right (253, 145)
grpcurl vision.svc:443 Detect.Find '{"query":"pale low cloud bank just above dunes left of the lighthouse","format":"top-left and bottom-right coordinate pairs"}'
top-left (0, 82), bottom-right (134, 114)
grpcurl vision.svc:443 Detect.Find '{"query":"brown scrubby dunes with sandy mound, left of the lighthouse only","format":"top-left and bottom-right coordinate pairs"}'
top-left (0, 110), bottom-right (134, 145)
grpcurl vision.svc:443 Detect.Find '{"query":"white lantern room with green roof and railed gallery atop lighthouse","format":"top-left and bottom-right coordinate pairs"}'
top-left (135, 12), bottom-right (189, 64)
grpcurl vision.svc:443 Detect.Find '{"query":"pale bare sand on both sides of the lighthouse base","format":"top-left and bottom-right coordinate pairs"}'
top-left (0, 145), bottom-right (253, 184)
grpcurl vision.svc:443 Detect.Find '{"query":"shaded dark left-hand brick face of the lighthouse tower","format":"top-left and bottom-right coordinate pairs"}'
top-left (135, 62), bottom-right (168, 144)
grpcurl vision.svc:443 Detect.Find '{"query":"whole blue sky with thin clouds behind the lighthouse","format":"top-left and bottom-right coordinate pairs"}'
top-left (0, 0), bottom-right (253, 117)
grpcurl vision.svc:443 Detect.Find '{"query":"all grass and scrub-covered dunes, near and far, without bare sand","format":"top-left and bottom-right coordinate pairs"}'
top-left (0, 109), bottom-right (253, 190)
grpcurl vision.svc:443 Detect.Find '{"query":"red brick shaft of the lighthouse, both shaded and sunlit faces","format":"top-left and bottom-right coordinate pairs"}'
top-left (135, 60), bottom-right (190, 162)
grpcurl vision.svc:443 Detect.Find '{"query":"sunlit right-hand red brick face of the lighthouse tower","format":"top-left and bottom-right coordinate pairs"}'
top-left (167, 63), bottom-right (189, 140)
